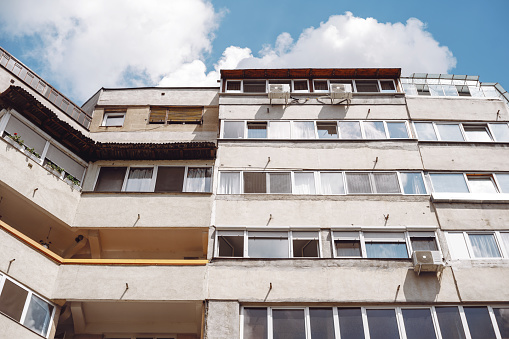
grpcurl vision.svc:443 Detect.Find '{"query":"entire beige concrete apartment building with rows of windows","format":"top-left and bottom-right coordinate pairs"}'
top-left (0, 45), bottom-right (509, 339)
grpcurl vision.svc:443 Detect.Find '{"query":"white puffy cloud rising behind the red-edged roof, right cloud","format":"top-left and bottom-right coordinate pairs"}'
top-left (237, 12), bottom-right (456, 74)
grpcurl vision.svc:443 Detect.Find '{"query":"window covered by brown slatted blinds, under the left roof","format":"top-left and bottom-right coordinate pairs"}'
top-left (148, 106), bottom-right (203, 124)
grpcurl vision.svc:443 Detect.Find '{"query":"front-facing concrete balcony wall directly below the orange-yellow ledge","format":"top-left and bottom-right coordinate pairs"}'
top-left (52, 265), bottom-right (206, 301)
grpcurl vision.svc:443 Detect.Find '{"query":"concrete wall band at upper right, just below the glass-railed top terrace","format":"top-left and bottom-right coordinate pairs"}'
top-left (407, 97), bottom-right (509, 121)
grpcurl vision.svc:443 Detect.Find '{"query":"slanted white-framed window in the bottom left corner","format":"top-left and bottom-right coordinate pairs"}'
top-left (0, 274), bottom-right (55, 337)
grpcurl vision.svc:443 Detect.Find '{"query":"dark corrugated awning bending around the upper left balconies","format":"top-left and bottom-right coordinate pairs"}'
top-left (0, 86), bottom-right (217, 161)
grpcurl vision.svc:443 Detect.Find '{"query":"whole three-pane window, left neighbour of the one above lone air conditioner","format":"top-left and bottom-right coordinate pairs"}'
top-left (215, 230), bottom-right (320, 258)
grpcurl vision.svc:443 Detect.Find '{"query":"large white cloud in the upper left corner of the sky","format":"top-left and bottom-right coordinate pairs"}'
top-left (0, 0), bottom-right (221, 99)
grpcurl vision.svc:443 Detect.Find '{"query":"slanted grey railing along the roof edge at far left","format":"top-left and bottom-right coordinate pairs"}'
top-left (0, 47), bottom-right (92, 130)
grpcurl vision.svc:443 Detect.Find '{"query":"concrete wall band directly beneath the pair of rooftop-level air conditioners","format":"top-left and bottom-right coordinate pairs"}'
top-left (219, 99), bottom-right (408, 120)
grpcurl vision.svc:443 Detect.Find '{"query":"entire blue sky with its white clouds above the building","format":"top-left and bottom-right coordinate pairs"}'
top-left (0, 0), bottom-right (509, 103)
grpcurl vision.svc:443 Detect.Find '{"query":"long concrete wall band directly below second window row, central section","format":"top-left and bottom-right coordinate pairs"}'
top-left (218, 140), bottom-right (422, 171)
